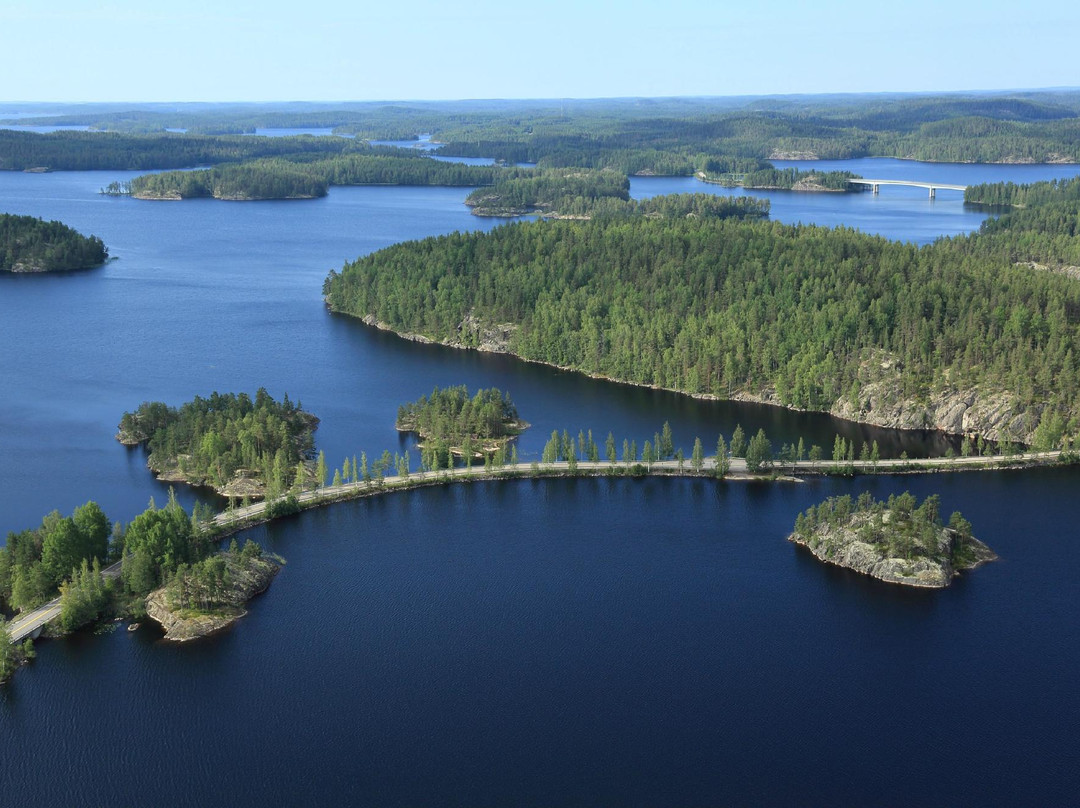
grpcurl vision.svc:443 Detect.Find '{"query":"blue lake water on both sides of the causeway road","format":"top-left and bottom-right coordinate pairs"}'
top-left (0, 163), bottom-right (1080, 805)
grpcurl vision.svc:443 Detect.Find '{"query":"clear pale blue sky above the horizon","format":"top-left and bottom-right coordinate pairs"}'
top-left (0, 0), bottom-right (1080, 102)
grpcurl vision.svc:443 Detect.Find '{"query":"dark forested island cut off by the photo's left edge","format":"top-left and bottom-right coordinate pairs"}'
top-left (0, 213), bottom-right (109, 272)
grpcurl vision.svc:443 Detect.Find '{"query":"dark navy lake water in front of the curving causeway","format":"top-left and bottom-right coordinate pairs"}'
top-left (0, 472), bottom-right (1080, 806)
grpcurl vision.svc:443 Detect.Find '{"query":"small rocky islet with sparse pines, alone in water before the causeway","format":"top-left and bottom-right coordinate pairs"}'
top-left (787, 493), bottom-right (998, 589)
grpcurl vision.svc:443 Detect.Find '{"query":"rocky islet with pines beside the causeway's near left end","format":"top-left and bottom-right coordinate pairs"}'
top-left (146, 541), bottom-right (281, 643)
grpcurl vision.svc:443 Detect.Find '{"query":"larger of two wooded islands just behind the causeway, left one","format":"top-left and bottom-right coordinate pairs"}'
top-left (117, 388), bottom-right (319, 498)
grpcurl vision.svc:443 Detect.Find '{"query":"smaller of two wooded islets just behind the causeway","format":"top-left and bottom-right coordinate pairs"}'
top-left (394, 385), bottom-right (528, 469)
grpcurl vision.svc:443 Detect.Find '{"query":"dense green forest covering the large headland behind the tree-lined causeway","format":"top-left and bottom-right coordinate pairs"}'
top-left (324, 189), bottom-right (1080, 441)
